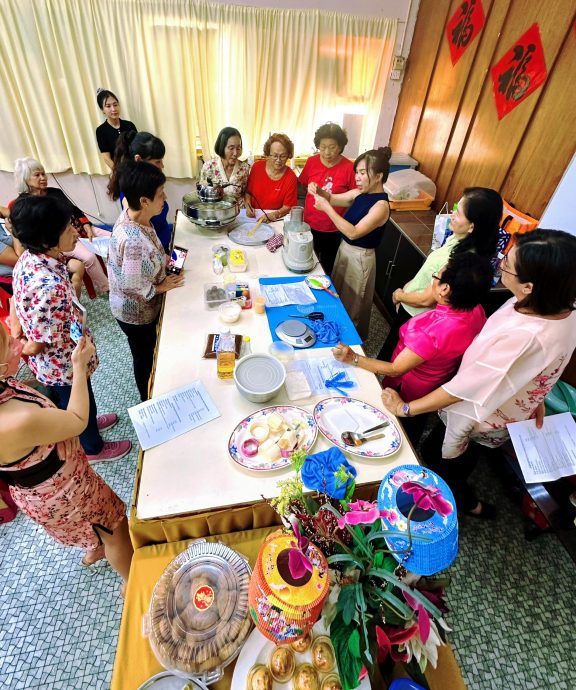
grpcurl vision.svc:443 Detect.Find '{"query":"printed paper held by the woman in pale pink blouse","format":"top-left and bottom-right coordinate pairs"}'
top-left (508, 412), bottom-right (576, 484)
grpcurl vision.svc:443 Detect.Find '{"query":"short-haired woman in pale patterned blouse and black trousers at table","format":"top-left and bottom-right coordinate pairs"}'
top-left (108, 161), bottom-right (184, 400)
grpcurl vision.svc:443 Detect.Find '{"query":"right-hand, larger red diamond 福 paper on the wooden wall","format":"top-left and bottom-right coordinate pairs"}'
top-left (492, 24), bottom-right (546, 120)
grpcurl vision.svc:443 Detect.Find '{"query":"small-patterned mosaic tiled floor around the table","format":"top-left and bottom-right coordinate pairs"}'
top-left (0, 298), bottom-right (576, 690)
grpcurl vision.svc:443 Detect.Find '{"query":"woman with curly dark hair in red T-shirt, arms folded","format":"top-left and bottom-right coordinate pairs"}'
top-left (298, 122), bottom-right (356, 275)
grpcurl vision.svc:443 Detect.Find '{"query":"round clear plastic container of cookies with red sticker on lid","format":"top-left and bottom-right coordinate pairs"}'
top-left (144, 539), bottom-right (252, 684)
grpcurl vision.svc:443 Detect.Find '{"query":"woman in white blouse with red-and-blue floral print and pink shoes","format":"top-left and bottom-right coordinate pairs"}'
top-left (11, 195), bottom-right (132, 462)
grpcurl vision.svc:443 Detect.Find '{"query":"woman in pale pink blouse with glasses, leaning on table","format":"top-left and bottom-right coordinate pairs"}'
top-left (382, 230), bottom-right (576, 518)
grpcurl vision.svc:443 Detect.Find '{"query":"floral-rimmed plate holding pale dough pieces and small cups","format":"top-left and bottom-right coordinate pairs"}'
top-left (228, 405), bottom-right (318, 472)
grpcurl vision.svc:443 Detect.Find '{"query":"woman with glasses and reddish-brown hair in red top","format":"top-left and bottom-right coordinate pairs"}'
top-left (245, 134), bottom-right (298, 221)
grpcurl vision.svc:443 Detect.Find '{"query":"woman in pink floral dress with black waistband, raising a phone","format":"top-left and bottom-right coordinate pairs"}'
top-left (0, 325), bottom-right (133, 581)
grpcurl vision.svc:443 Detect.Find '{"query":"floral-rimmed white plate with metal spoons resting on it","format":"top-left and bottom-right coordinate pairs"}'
top-left (314, 398), bottom-right (402, 458)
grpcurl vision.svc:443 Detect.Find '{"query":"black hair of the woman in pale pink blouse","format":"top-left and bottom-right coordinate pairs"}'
top-left (514, 229), bottom-right (576, 316)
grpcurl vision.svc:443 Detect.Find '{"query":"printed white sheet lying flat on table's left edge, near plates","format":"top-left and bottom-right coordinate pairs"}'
top-left (128, 381), bottom-right (220, 450)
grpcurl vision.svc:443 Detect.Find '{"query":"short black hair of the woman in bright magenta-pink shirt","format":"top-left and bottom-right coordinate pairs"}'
top-left (440, 252), bottom-right (494, 311)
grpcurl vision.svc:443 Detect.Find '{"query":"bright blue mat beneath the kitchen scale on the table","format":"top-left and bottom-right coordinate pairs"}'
top-left (259, 276), bottom-right (362, 349)
